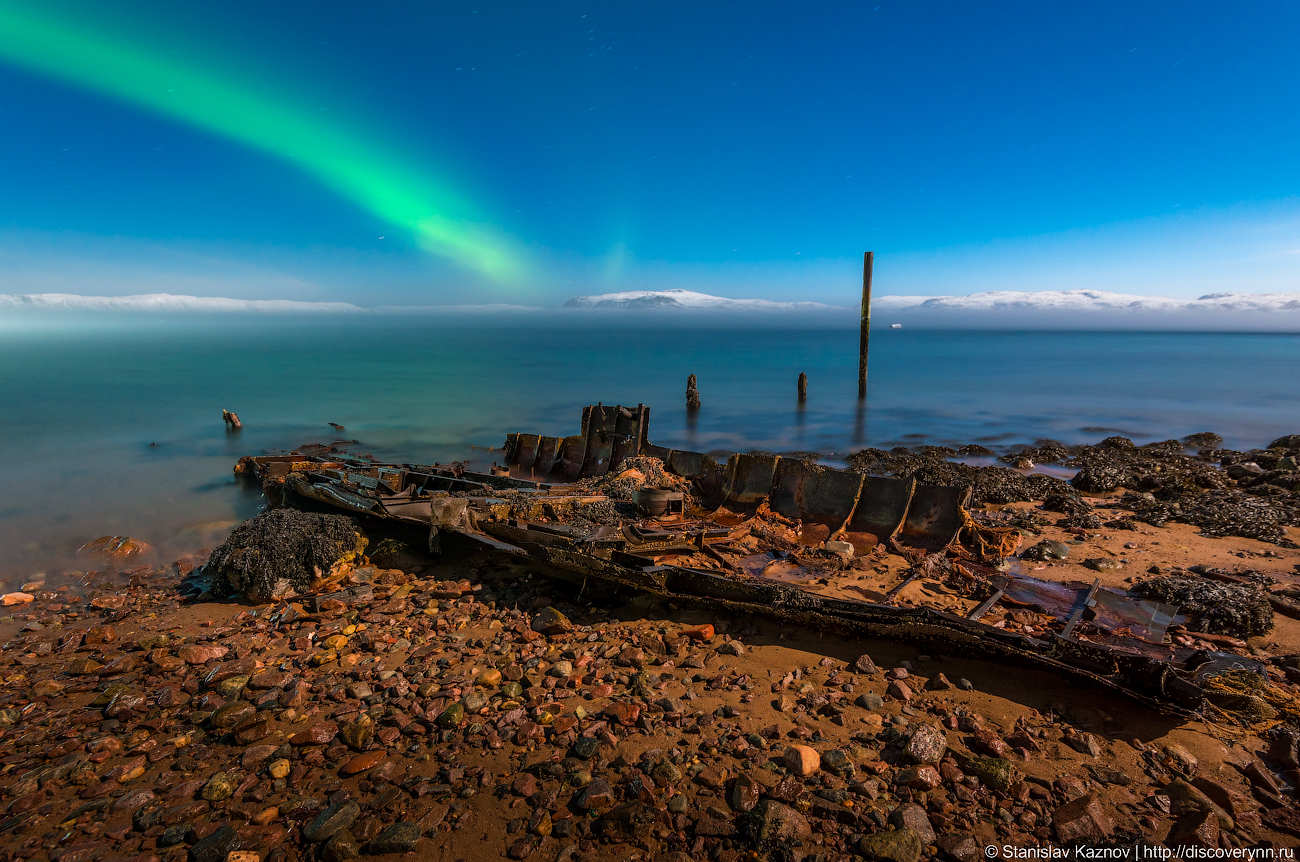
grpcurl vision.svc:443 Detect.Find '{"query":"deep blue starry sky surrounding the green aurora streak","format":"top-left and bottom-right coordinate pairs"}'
top-left (0, 0), bottom-right (1300, 304)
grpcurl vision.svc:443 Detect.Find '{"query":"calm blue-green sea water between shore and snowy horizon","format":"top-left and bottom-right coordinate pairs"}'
top-left (0, 317), bottom-right (1300, 589)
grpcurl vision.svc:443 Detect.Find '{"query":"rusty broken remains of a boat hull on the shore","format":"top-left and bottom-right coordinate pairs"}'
top-left (226, 404), bottom-right (1258, 711)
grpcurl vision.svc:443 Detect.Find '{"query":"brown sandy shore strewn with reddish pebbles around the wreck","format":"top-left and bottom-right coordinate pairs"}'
top-left (0, 504), bottom-right (1300, 862)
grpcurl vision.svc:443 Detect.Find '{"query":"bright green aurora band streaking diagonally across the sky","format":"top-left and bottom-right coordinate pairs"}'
top-left (0, 3), bottom-right (521, 283)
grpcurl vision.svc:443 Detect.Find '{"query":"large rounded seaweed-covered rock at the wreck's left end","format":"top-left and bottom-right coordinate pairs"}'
top-left (208, 508), bottom-right (367, 602)
